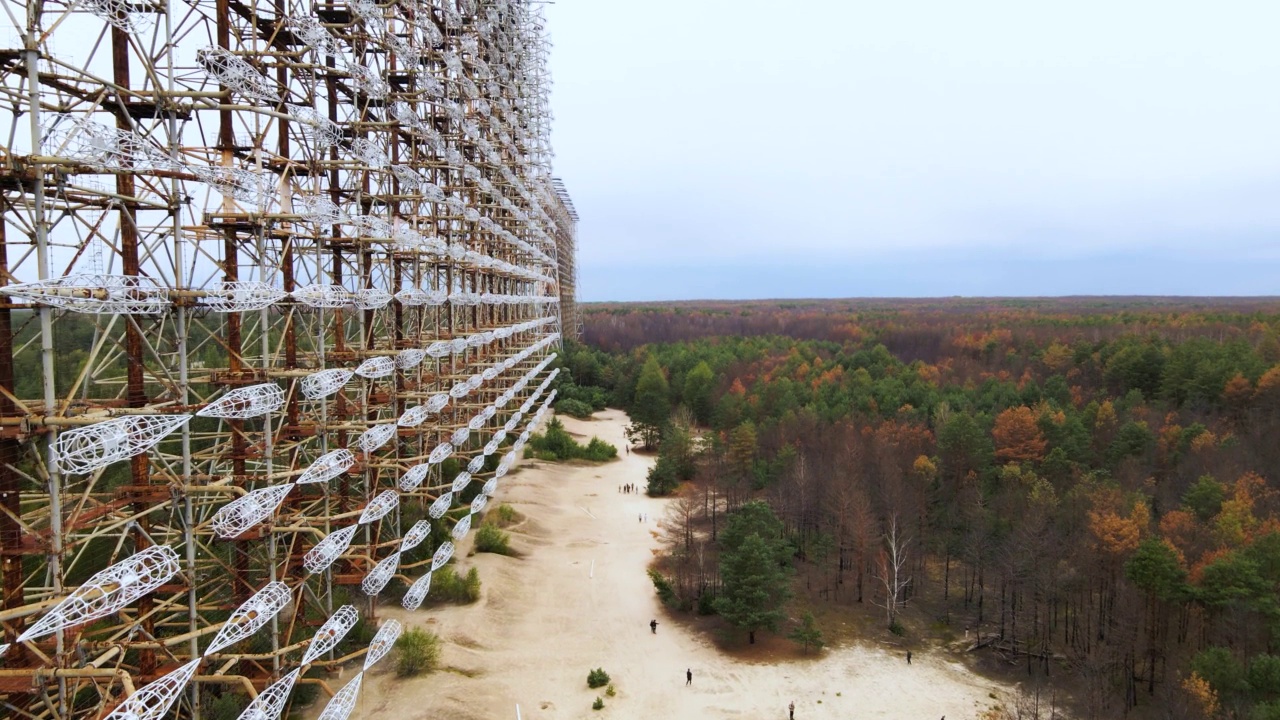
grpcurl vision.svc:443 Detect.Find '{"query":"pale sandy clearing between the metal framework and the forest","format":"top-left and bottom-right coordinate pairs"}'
top-left (350, 410), bottom-right (1002, 720)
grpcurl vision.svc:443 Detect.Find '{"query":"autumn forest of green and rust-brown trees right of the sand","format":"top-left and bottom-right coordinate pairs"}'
top-left (559, 297), bottom-right (1280, 720)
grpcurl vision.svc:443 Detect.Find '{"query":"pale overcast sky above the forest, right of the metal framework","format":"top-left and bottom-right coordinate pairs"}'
top-left (547, 0), bottom-right (1280, 300)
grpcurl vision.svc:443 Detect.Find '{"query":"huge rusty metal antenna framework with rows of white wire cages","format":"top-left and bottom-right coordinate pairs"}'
top-left (0, 0), bottom-right (577, 720)
